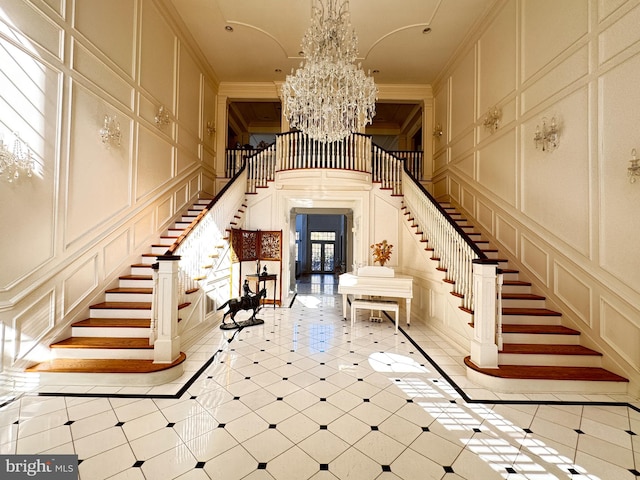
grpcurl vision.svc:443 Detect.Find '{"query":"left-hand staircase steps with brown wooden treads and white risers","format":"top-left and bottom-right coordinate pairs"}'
top-left (26, 199), bottom-right (246, 384)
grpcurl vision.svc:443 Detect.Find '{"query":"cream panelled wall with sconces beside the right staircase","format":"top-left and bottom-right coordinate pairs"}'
top-left (434, 0), bottom-right (640, 392)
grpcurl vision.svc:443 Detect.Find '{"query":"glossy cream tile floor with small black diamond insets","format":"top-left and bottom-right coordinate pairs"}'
top-left (0, 276), bottom-right (640, 480)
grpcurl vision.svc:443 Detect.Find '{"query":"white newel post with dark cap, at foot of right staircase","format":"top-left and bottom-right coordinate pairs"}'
top-left (471, 259), bottom-right (498, 368)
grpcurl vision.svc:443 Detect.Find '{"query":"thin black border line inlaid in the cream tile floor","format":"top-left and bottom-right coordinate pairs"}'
top-left (0, 293), bottom-right (640, 413)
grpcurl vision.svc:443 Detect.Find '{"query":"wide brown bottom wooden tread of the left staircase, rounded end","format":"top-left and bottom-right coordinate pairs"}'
top-left (26, 352), bottom-right (187, 373)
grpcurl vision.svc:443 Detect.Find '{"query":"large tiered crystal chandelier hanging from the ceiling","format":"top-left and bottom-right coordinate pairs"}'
top-left (282, 0), bottom-right (378, 142)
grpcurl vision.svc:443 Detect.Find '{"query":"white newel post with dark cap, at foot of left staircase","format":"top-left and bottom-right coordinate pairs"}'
top-left (153, 255), bottom-right (180, 363)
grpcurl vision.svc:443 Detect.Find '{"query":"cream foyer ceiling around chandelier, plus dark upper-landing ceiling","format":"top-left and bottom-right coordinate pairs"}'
top-left (166, 0), bottom-right (496, 135)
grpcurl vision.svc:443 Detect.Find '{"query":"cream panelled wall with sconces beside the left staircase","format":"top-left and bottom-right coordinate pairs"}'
top-left (0, 0), bottom-right (217, 384)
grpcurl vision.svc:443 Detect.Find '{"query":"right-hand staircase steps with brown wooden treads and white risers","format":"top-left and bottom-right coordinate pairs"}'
top-left (404, 203), bottom-right (628, 393)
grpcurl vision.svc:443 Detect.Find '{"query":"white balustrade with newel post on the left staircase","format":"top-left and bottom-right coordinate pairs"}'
top-left (150, 166), bottom-right (247, 363)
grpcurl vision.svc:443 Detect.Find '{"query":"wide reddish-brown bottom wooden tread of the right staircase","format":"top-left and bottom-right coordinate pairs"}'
top-left (464, 357), bottom-right (629, 382)
